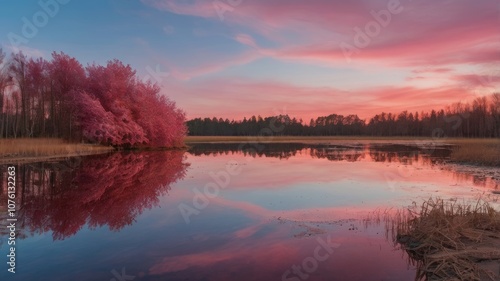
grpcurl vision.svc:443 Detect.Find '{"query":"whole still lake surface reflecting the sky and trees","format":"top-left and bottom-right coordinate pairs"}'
top-left (0, 144), bottom-right (499, 281)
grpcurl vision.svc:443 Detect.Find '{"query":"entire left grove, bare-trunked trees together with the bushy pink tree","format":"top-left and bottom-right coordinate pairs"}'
top-left (0, 49), bottom-right (186, 147)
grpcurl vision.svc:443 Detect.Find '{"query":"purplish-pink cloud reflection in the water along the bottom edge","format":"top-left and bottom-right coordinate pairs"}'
top-left (149, 219), bottom-right (414, 281)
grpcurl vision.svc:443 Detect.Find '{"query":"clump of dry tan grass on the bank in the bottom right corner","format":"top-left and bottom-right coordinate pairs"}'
top-left (391, 199), bottom-right (500, 280)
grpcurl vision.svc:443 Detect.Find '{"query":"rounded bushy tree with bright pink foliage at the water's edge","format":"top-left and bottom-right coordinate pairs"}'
top-left (70, 60), bottom-right (186, 147)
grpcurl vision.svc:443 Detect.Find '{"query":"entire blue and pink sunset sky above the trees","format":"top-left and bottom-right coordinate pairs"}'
top-left (0, 0), bottom-right (500, 122)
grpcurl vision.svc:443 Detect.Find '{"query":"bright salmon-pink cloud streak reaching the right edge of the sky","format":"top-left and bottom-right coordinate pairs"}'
top-left (274, 34), bottom-right (500, 67)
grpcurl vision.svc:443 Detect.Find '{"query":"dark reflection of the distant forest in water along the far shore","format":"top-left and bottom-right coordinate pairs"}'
top-left (188, 142), bottom-right (500, 190)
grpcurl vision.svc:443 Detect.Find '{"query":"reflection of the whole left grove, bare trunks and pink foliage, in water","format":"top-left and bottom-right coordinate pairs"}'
top-left (0, 151), bottom-right (187, 240)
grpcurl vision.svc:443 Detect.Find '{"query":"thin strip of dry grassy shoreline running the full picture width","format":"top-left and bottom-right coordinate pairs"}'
top-left (0, 136), bottom-right (500, 165)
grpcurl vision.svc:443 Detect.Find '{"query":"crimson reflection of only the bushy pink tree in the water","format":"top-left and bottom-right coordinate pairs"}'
top-left (19, 151), bottom-right (187, 239)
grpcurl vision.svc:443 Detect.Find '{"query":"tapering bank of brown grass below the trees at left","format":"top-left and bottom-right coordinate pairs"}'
top-left (0, 138), bottom-right (113, 162)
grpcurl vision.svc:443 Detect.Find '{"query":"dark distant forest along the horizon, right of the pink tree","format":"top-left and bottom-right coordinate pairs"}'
top-left (187, 93), bottom-right (500, 138)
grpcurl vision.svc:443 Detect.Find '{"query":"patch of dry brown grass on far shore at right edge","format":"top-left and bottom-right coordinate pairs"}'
top-left (451, 140), bottom-right (500, 166)
